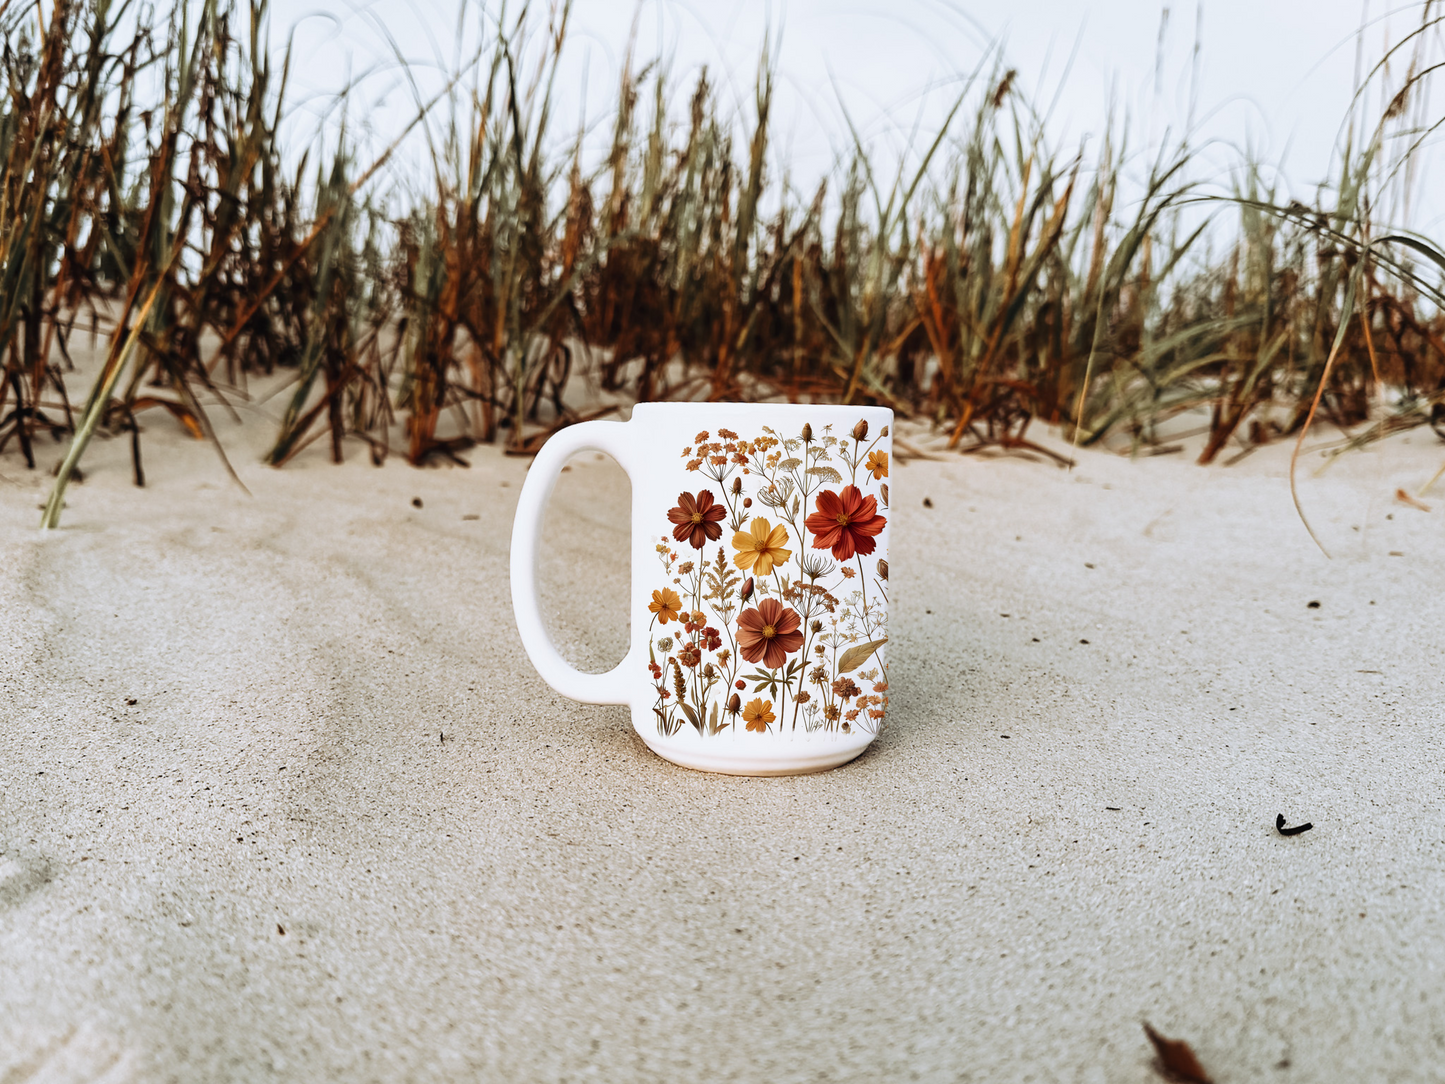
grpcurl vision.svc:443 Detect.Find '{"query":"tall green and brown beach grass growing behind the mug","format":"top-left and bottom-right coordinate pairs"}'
top-left (8, 0), bottom-right (1445, 526)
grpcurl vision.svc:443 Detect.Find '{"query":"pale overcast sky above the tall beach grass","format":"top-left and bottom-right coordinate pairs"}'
top-left (284, 0), bottom-right (1439, 227)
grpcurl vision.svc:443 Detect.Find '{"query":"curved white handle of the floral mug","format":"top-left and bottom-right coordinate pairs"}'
top-left (512, 422), bottom-right (633, 704)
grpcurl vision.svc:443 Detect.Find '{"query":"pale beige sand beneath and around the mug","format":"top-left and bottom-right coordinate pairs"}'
top-left (0, 416), bottom-right (1445, 1084)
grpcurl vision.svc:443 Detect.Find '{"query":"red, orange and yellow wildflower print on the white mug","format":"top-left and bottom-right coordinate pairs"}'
top-left (647, 421), bottom-right (889, 737)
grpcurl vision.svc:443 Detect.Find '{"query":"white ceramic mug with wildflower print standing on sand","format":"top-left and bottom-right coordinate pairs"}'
top-left (512, 403), bottom-right (893, 775)
